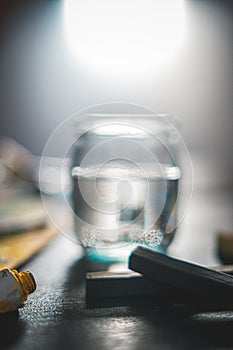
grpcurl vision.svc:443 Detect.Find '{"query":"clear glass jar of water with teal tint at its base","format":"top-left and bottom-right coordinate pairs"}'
top-left (72, 106), bottom-right (181, 261)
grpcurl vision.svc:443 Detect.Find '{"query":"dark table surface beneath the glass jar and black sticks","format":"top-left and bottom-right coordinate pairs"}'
top-left (0, 190), bottom-right (233, 350)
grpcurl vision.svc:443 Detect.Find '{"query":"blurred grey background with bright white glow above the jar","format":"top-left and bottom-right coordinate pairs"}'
top-left (0, 0), bottom-right (233, 186)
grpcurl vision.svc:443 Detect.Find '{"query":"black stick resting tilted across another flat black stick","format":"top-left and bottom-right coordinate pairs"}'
top-left (129, 247), bottom-right (233, 306)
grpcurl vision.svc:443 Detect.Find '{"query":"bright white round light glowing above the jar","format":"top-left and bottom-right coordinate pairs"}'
top-left (65, 0), bottom-right (184, 76)
